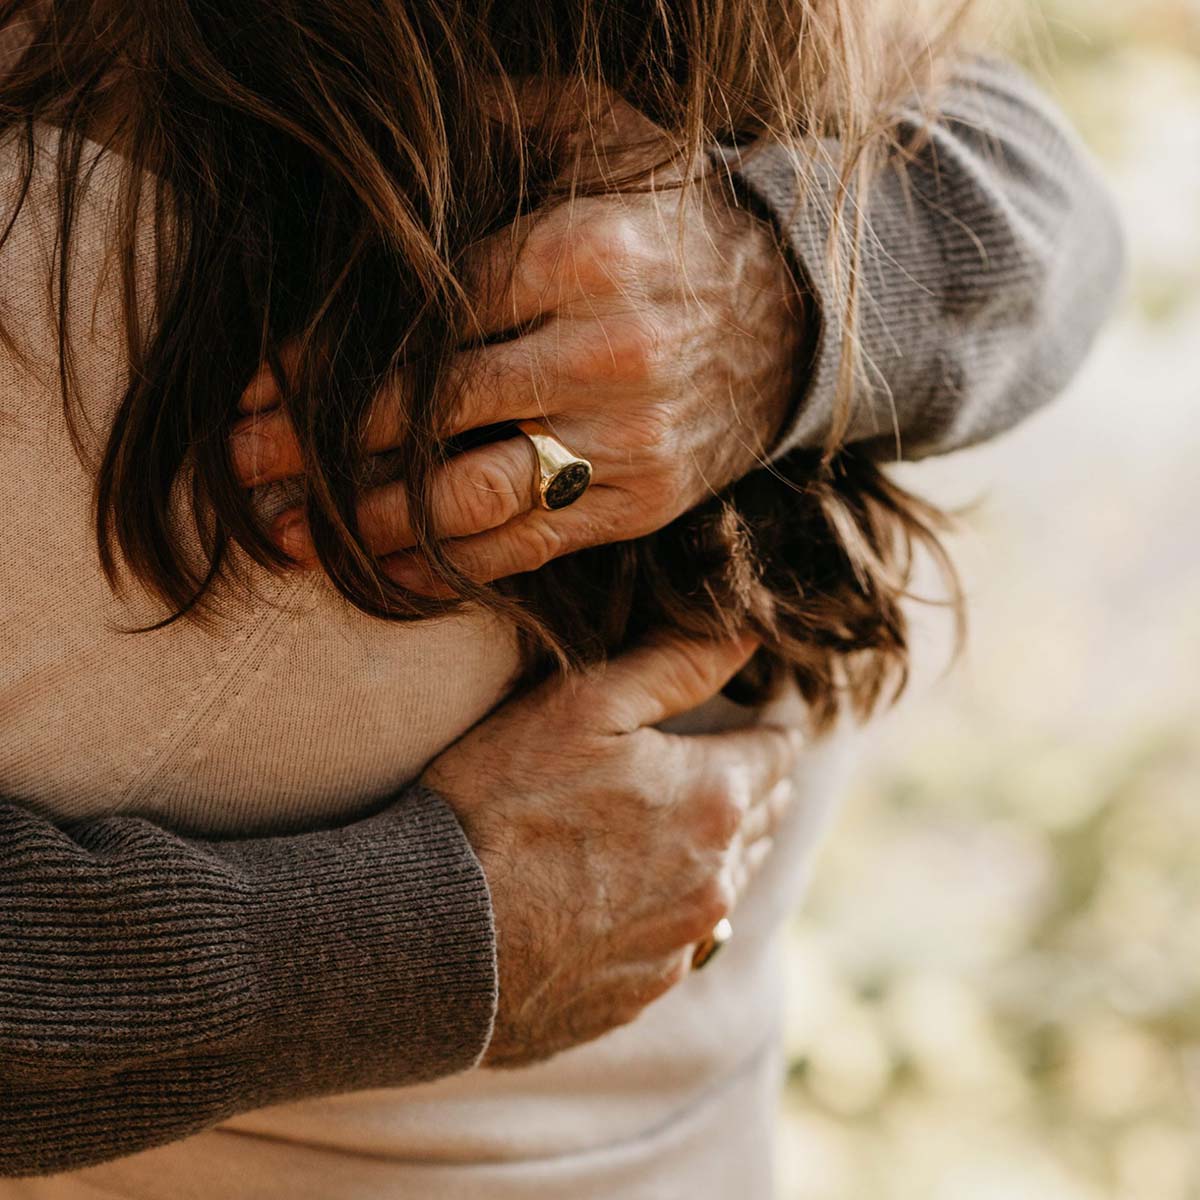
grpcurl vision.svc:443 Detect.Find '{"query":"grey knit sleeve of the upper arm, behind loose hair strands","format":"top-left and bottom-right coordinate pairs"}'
top-left (724, 59), bottom-right (1124, 458)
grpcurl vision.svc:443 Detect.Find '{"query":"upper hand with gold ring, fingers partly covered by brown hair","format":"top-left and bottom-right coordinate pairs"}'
top-left (233, 102), bottom-right (803, 592)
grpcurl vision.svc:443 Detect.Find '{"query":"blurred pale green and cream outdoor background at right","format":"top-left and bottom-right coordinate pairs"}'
top-left (780, 0), bottom-right (1200, 1200)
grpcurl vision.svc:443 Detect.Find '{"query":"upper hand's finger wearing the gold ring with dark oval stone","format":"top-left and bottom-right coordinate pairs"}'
top-left (272, 437), bottom-right (536, 561)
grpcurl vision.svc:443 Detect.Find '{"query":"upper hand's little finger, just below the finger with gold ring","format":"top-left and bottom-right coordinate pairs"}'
top-left (384, 487), bottom-right (624, 596)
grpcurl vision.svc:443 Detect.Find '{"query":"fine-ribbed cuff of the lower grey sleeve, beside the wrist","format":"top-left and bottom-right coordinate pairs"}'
top-left (226, 787), bottom-right (497, 1103)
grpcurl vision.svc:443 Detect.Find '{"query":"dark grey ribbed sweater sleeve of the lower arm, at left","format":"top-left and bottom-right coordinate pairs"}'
top-left (0, 787), bottom-right (497, 1175)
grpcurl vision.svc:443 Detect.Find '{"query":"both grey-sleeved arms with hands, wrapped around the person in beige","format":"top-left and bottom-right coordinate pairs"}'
top-left (0, 61), bottom-right (1121, 1175)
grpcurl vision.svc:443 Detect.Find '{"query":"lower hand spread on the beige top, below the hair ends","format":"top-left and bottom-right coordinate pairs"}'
top-left (422, 637), bottom-right (800, 1067)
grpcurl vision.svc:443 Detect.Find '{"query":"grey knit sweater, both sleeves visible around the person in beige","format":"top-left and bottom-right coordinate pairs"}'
top-left (0, 54), bottom-right (1122, 1175)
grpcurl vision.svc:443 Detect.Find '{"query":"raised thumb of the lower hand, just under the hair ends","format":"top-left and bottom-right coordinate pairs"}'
top-left (594, 634), bottom-right (758, 736)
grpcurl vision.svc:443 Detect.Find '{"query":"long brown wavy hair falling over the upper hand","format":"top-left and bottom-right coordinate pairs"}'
top-left (0, 0), bottom-right (961, 725)
